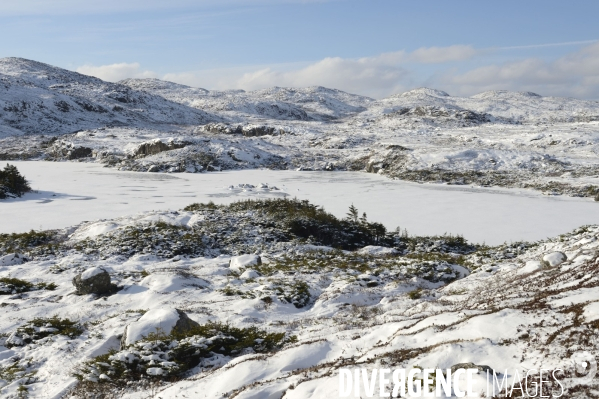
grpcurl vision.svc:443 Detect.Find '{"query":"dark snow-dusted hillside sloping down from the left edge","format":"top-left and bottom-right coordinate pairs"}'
top-left (0, 58), bottom-right (220, 137)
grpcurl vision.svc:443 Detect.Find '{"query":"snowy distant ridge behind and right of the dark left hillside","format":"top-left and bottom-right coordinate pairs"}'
top-left (119, 79), bottom-right (375, 121)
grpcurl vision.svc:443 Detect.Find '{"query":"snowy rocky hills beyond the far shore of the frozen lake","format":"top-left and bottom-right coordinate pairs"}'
top-left (0, 58), bottom-right (599, 198)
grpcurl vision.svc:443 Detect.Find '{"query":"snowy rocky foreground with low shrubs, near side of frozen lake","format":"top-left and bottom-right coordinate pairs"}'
top-left (0, 199), bottom-right (599, 398)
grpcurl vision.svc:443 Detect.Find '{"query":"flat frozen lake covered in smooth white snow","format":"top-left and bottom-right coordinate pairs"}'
top-left (0, 162), bottom-right (599, 244)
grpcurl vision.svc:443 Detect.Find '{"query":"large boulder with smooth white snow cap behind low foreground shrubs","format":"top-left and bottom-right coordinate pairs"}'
top-left (121, 308), bottom-right (199, 349)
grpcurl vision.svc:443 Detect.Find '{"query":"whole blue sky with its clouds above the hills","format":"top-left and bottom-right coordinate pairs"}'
top-left (0, 0), bottom-right (599, 99)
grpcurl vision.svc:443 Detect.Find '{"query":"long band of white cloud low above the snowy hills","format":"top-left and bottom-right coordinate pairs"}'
top-left (72, 42), bottom-right (599, 99)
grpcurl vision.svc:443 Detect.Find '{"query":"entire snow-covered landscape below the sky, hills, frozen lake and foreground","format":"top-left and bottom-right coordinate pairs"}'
top-left (0, 58), bottom-right (599, 399)
